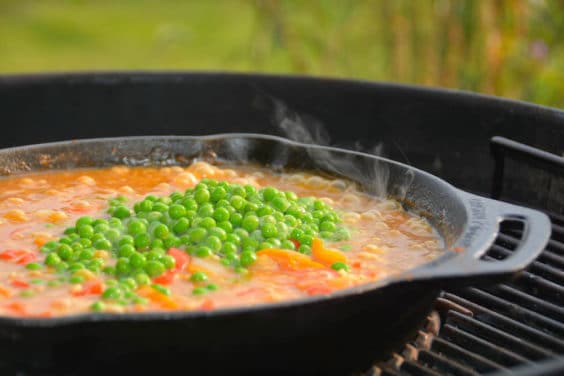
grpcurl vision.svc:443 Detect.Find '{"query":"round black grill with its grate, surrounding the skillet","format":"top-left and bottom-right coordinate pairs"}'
top-left (0, 73), bottom-right (564, 375)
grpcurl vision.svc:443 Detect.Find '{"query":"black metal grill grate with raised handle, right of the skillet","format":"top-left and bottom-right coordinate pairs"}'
top-left (366, 138), bottom-right (564, 376)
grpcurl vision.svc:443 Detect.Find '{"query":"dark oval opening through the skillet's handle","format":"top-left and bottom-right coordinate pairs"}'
top-left (480, 217), bottom-right (525, 261)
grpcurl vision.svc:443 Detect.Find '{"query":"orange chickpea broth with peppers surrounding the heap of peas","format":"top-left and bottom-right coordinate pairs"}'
top-left (0, 162), bottom-right (442, 317)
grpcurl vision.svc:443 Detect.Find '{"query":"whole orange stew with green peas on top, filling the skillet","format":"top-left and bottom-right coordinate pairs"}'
top-left (0, 162), bottom-right (442, 317)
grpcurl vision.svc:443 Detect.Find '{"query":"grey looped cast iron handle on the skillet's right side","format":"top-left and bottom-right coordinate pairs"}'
top-left (413, 192), bottom-right (551, 280)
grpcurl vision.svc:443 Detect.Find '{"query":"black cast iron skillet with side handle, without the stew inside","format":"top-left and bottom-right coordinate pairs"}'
top-left (0, 134), bottom-right (550, 374)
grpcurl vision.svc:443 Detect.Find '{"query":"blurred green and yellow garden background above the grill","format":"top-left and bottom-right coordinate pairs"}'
top-left (0, 0), bottom-right (564, 108)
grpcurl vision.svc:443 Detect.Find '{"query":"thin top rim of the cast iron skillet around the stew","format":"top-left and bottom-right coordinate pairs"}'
top-left (0, 132), bottom-right (480, 328)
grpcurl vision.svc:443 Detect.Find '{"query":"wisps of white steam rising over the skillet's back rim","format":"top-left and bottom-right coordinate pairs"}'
top-left (269, 97), bottom-right (398, 198)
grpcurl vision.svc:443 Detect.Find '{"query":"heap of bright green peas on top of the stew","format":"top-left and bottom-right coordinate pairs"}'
top-left (36, 179), bottom-right (350, 309)
